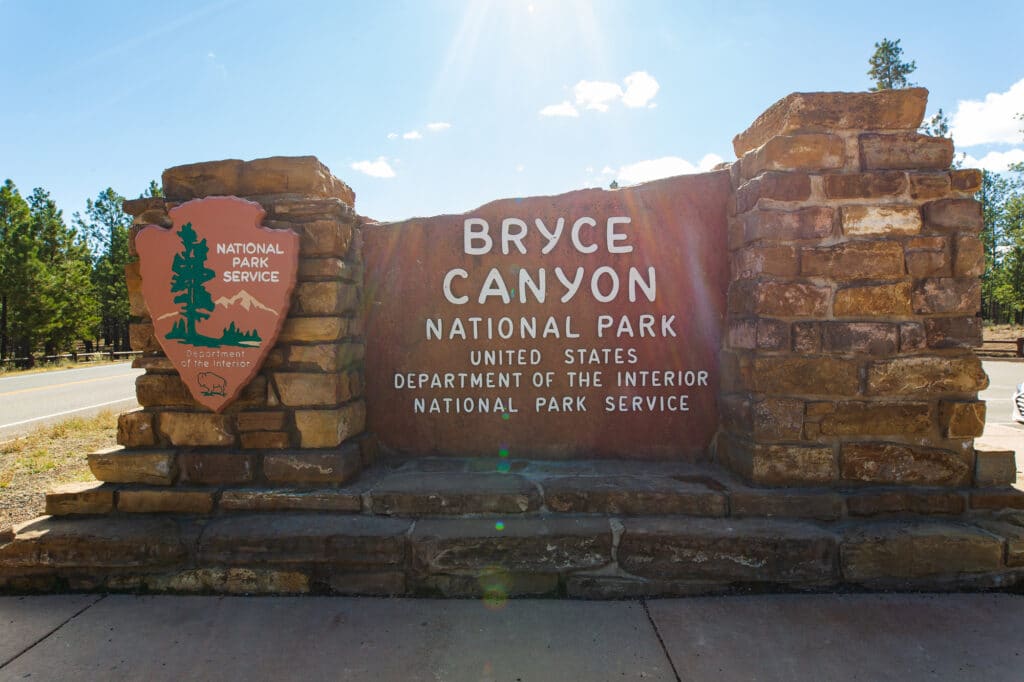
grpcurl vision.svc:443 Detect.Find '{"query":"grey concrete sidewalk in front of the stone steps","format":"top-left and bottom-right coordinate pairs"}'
top-left (0, 594), bottom-right (1024, 682)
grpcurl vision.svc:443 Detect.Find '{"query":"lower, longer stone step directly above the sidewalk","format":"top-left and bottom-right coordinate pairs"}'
top-left (0, 512), bottom-right (1024, 597)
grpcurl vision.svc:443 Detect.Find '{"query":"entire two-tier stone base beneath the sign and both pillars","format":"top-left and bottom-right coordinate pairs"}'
top-left (0, 460), bottom-right (1024, 599)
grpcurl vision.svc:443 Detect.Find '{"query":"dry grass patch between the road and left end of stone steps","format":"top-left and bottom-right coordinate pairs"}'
top-left (0, 410), bottom-right (118, 527)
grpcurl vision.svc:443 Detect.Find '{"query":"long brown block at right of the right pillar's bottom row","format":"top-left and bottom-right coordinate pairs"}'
top-left (840, 442), bottom-right (971, 485)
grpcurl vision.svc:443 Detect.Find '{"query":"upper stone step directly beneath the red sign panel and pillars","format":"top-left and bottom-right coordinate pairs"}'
top-left (39, 468), bottom-right (1024, 521)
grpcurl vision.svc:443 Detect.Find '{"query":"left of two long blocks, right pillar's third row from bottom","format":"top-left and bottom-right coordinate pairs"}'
top-left (749, 356), bottom-right (860, 395)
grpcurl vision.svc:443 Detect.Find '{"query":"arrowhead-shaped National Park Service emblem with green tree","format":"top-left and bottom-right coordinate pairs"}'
top-left (135, 197), bottom-right (299, 412)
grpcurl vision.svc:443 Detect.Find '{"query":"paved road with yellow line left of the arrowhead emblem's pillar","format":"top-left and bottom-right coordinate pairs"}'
top-left (0, 363), bottom-right (142, 442)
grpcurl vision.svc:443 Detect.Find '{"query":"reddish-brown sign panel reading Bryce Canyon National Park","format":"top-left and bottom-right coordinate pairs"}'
top-left (364, 172), bottom-right (729, 459)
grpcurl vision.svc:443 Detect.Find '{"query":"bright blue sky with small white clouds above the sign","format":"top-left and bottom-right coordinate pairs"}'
top-left (0, 0), bottom-right (1024, 219)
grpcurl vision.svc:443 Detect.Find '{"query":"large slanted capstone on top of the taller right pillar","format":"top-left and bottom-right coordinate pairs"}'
top-left (732, 88), bottom-right (928, 157)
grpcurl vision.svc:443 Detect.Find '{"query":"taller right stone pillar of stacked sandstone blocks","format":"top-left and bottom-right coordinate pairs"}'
top-left (718, 88), bottom-right (988, 486)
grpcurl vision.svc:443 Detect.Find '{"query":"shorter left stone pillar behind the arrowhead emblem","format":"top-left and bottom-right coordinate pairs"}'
top-left (109, 157), bottom-right (366, 484)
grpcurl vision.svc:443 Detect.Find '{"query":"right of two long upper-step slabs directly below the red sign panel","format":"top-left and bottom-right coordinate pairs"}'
top-left (542, 475), bottom-right (728, 516)
